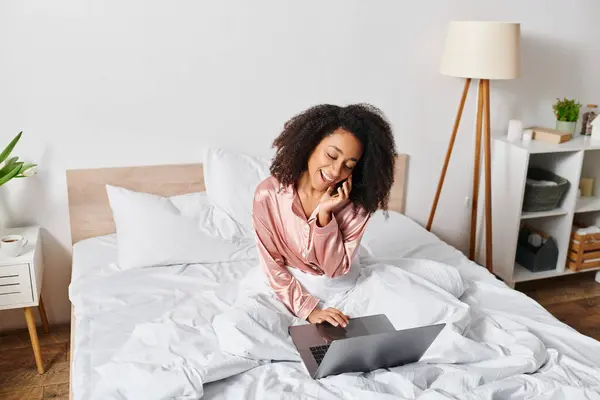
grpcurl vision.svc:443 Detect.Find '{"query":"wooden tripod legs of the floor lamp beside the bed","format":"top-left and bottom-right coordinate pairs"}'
top-left (426, 78), bottom-right (493, 272)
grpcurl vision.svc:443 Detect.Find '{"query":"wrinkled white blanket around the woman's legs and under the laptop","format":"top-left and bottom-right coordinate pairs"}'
top-left (71, 259), bottom-right (600, 400)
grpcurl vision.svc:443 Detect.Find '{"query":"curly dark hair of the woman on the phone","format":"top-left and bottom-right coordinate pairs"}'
top-left (271, 104), bottom-right (397, 213)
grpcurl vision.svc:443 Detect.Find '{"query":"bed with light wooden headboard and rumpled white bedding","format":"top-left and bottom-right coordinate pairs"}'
top-left (67, 155), bottom-right (600, 400)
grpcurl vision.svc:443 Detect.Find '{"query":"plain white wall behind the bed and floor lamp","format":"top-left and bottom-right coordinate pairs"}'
top-left (0, 0), bottom-right (600, 328)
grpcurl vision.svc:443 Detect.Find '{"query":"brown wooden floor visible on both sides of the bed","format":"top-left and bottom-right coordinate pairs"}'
top-left (0, 273), bottom-right (600, 400)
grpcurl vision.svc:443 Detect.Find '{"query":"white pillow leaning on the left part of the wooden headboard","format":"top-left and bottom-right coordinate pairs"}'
top-left (106, 185), bottom-right (256, 270)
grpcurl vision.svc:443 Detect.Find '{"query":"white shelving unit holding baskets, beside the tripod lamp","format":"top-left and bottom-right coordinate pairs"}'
top-left (492, 136), bottom-right (600, 286)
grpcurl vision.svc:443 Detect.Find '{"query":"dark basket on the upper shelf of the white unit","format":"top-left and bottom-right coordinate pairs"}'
top-left (523, 168), bottom-right (570, 212)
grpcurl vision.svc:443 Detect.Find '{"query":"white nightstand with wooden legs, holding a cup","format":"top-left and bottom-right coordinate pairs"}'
top-left (0, 226), bottom-right (49, 374)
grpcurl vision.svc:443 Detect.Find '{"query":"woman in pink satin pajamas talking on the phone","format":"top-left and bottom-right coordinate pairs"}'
top-left (253, 104), bottom-right (397, 326)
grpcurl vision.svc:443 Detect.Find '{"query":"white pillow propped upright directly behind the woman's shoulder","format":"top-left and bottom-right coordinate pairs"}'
top-left (204, 148), bottom-right (270, 237)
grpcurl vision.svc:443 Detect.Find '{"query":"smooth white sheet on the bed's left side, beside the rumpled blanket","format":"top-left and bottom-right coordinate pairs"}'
top-left (69, 235), bottom-right (255, 399)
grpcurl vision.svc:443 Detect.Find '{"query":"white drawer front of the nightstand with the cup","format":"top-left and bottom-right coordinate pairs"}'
top-left (0, 264), bottom-right (33, 306)
